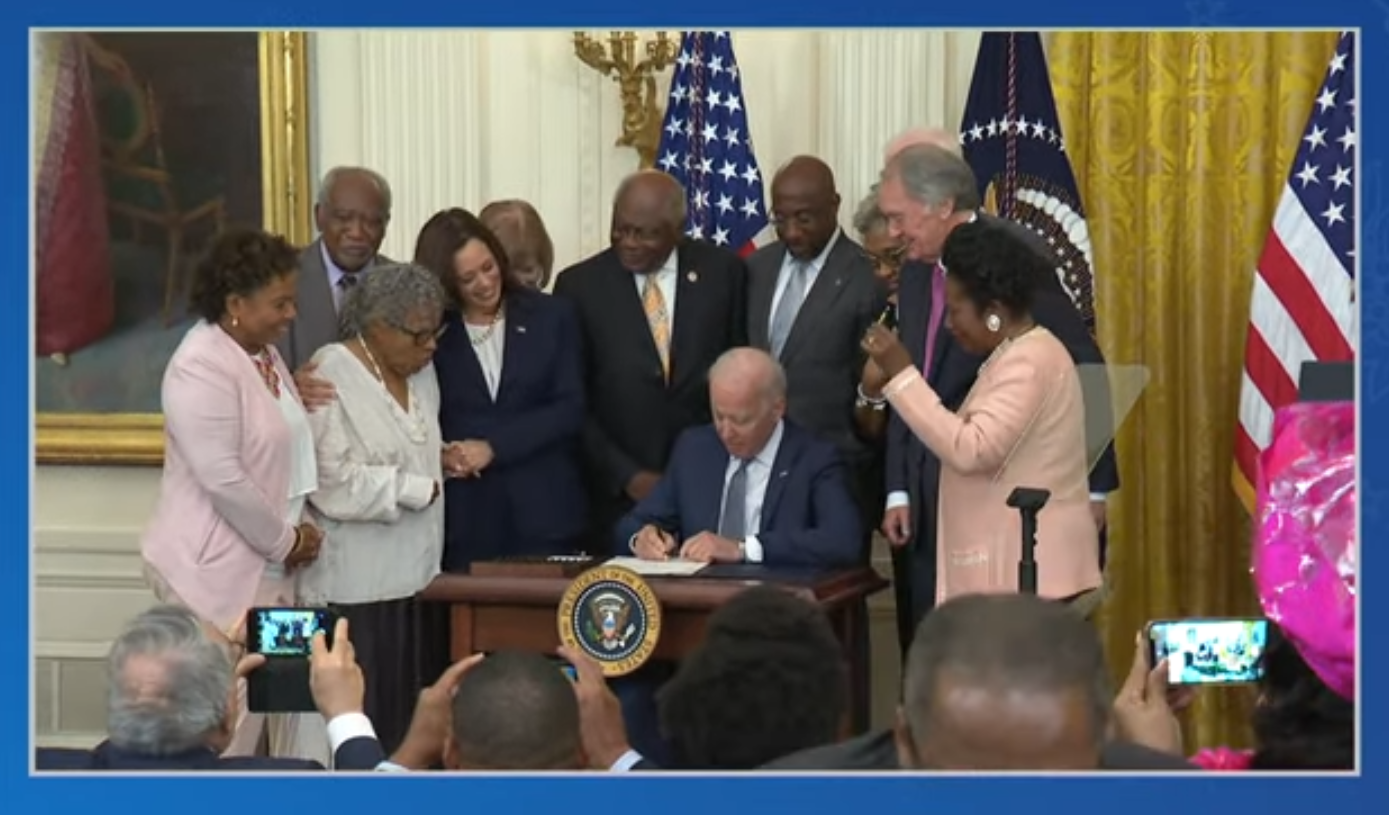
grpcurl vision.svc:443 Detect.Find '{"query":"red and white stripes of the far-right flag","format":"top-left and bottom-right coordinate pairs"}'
top-left (1235, 186), bottom-right (1356, 508)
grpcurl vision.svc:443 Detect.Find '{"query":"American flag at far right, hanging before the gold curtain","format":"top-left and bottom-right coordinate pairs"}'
top-left (1235, 32), bottom-right (1356, 510)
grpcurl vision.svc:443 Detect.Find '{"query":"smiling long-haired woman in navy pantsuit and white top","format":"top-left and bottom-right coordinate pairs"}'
top-left (415, 208), bottom-right (588, 572)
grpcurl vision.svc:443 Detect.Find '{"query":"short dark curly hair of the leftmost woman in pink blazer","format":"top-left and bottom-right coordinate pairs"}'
top-left (189, 228), bottom-right (299, 322)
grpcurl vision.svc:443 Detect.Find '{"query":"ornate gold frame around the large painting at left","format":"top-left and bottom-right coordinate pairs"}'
top-left (35, 32), bottom-right (313, 465)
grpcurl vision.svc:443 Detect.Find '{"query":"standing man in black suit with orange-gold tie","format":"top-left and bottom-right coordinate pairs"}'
top-left (554, 171), bottom-right (747, 555)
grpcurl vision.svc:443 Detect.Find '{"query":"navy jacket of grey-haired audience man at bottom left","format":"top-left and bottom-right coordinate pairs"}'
top-left (35, 736), bottom-right (386, 772)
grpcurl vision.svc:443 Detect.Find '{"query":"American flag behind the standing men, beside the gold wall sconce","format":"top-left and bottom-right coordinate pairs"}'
top-left (656, 31), bottom-right (768, 255)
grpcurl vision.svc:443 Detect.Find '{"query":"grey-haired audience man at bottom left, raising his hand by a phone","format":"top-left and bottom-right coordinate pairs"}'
top-left (36, 605), bottom-right (386, 772)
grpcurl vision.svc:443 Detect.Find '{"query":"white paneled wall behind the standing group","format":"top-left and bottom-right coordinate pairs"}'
top-left (33, 31), bottom-right (979, 744)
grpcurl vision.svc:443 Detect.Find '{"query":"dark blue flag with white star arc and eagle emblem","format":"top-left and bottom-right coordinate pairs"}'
top-left (960, 32), bottom-right (1095, 330)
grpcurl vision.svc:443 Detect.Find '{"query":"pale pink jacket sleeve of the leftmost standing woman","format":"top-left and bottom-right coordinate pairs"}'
top-left (164, 347), bottom-right (294, 562)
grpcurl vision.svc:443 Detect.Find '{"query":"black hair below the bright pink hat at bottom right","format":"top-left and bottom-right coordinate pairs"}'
top-left (1253, 623), bottom-right (1356, 771)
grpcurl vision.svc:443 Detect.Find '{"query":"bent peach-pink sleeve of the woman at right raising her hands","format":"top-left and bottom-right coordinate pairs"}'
top-left (883, 348), bottom-right (1047, 475)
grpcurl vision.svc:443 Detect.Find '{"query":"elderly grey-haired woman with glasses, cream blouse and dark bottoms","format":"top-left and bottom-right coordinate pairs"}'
top-left (300, 264), bottom-right (444, 753)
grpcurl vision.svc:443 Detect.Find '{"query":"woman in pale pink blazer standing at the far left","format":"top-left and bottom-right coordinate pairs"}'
top-left (140, 230), bottom-right (326, 757)
